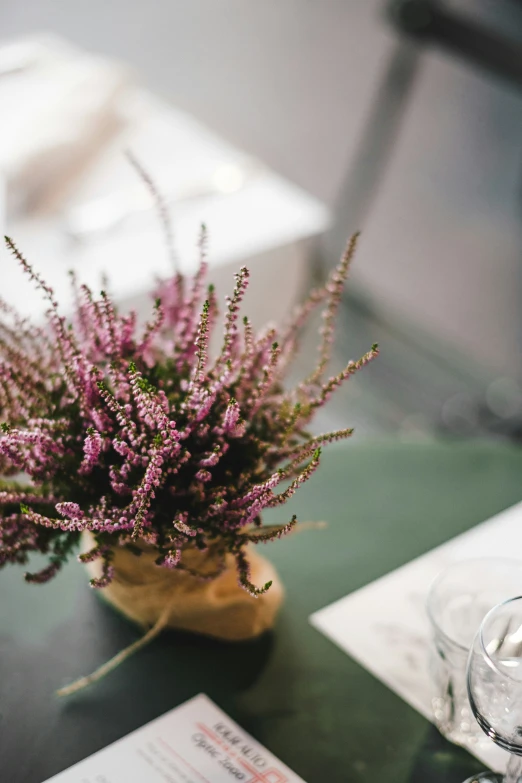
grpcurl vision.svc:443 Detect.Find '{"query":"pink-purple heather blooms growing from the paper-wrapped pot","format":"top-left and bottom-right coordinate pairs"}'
top-left (0, 229), bottom-right (378, 596)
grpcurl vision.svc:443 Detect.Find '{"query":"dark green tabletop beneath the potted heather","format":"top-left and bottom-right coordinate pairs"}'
top-left (0, 441), bottom-right (522, 783)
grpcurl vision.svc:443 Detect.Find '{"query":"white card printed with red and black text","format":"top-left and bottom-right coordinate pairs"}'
top-left (46, 694), bottom-right (304, 783)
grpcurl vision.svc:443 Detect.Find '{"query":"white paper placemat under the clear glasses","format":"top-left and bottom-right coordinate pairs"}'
top-left (310, 503), bottom-right (522, 771)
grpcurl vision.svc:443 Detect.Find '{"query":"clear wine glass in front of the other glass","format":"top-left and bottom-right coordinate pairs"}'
top-left (466, 597), bottom-right (522, 783)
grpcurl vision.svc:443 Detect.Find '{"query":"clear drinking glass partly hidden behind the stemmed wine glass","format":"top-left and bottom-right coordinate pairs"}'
top-left (427, 557), bottom-right (522, 749)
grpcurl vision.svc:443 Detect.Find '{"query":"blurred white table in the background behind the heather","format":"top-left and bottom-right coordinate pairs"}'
top-left (1, 72), bottom-right (329, 325)
